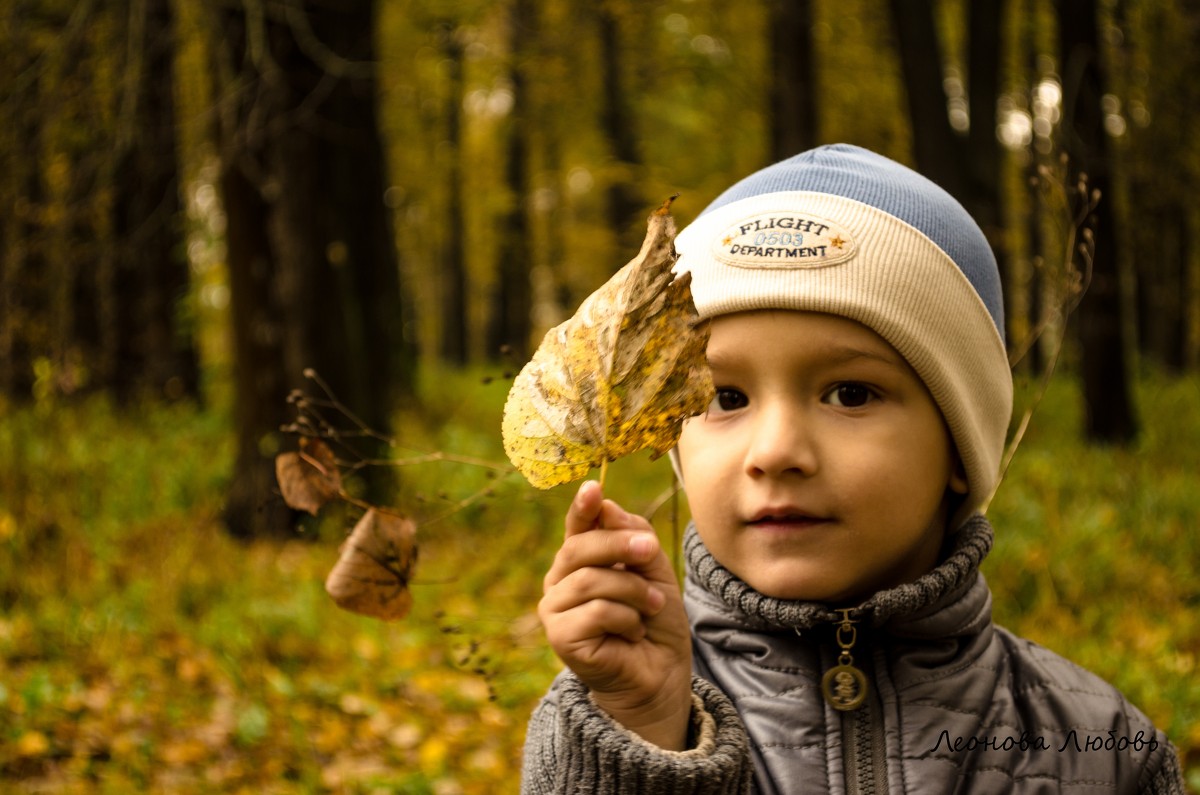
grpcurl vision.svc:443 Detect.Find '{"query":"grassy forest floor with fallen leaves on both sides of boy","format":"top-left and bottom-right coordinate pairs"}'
top-left (0, 373), bottom-right (1200, 795)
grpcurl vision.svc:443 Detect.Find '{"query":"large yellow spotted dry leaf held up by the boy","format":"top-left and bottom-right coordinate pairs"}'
top-left (503, 199), bottom-right (713, 489)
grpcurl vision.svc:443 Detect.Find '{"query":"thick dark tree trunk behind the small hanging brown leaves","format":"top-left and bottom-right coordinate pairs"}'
top-left (218, 0), bottom-right (413, 536)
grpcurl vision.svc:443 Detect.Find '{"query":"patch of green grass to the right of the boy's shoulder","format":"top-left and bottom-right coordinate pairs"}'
top-left (984, 376), bottom-right (1200, 791)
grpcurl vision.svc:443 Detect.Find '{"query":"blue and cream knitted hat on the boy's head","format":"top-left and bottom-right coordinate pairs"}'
top-left (672, 144), bottom-right (1013, 528)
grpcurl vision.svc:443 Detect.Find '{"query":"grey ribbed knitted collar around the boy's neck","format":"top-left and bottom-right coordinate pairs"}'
top-left (684, 514), bottom-right (992, 635)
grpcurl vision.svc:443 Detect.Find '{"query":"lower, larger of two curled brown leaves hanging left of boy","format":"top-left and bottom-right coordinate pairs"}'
top-left (325, 508), bottom-right (416, 621)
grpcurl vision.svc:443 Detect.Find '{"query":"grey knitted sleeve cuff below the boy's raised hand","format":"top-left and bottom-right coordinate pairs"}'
top-left (521, 671), bottom-right (754, 795)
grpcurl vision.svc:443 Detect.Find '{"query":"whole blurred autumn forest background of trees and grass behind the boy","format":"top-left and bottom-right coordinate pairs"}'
top-left (0, 0), bottom-right (1200, 795)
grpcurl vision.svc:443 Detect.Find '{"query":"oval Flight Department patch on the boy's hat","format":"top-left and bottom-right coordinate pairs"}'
top-left (713, 213), bottom-right (854, 268)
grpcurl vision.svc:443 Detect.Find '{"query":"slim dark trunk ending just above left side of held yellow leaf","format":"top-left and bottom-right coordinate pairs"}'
top-left (487, 0), bottom-right (536, 361)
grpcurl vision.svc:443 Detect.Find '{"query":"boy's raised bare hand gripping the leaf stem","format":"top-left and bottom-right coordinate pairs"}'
top-left (538, 482), bottom-right (691, 751)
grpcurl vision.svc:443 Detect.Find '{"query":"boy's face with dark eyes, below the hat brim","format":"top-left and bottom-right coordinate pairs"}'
top-left (679, 311), bottom-right (967, 603)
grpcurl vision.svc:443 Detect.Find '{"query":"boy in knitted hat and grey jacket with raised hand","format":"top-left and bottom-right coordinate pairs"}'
top-left (523, 145), bottom-right (1184, 794)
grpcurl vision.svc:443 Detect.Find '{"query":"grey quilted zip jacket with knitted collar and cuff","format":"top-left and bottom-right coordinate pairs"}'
top-left (522, 516), bottom-right (1186, 795)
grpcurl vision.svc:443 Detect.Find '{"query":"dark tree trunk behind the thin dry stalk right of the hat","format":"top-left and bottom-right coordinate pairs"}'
top-left (1057, 0), bottom-right (1138, 443)
